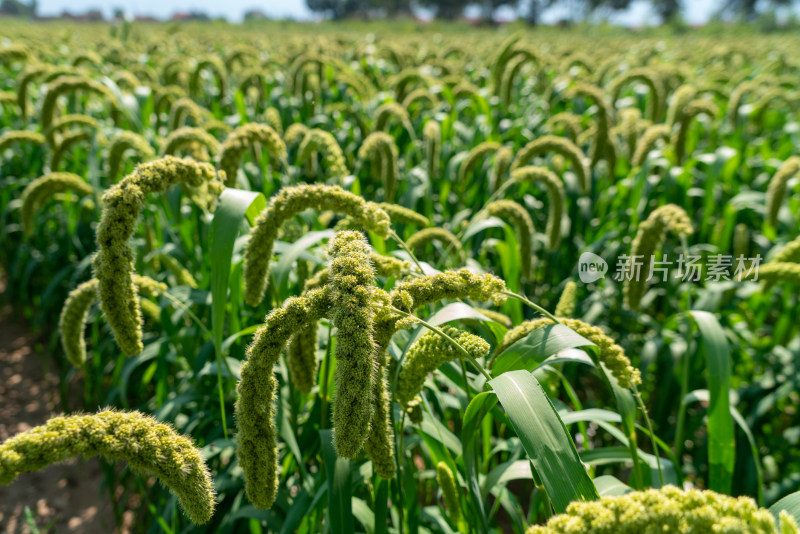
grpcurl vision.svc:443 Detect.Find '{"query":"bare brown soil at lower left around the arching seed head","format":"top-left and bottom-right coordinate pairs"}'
top-left (0, 288), bottom-right (132, 534)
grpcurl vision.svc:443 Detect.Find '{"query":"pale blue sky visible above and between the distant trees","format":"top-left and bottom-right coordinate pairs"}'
top-left (34, 0), bottom-right (718, 25)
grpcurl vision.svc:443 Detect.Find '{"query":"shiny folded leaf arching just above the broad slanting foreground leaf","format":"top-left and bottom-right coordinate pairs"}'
top-left (492, 324), bottom-right (594, 376)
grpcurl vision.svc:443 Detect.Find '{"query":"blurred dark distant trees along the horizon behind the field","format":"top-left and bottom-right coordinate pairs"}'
top-left (304, 0), bottom-right (800, 24)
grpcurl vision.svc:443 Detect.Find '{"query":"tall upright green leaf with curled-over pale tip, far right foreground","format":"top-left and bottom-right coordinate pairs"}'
top-left (687, 310), bottom-right (736, 495)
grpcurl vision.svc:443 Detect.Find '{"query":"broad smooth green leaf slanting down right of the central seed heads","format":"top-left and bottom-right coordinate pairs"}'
top-left (489, 370), bottom-right (598, 513)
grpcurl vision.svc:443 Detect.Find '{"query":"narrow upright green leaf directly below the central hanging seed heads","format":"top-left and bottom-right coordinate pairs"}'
top-left (319, 430), bottom-right (355, 533)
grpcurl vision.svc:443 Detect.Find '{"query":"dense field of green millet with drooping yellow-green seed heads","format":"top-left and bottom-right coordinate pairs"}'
top-left (0, 22), bottom-right (800, 533)
